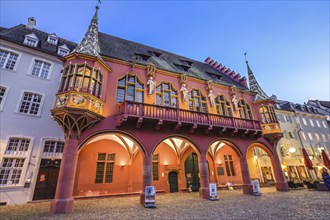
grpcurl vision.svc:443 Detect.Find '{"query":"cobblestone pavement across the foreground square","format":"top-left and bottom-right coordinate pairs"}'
top-left (0, 188), bottom-right (330, 220)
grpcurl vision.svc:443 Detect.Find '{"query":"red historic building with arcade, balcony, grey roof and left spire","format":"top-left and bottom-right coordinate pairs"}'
top-left (49, 8), bottom-right (288, 213)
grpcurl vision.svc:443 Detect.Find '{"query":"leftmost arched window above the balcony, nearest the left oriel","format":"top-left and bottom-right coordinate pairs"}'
top-left (117, 74), bottom-right (144, 103)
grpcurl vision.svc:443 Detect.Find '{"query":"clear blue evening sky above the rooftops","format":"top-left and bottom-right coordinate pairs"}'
top-left (0, 0), bottom-right (330, 103)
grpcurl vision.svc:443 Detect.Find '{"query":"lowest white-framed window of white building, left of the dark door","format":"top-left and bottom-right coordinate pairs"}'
top-left (0, 158), bottom-right (25, 185)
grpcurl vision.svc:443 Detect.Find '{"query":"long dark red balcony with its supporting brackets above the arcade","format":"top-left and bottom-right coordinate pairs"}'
top-left (117, 101), bottom-right (262, 136)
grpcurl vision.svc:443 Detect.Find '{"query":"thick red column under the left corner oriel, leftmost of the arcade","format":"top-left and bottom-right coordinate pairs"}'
top-left (50, 139), bottom-right (78, 214)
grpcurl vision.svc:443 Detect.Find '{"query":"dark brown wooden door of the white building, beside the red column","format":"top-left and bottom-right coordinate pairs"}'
top-left (33, 159), bottom-right (61, 200)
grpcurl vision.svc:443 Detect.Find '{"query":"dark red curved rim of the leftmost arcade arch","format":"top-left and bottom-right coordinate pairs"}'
top-left (78, 130), bottom-right (148, 156)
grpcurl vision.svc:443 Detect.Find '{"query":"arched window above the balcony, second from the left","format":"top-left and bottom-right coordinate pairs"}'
top-left (156, 82), bottom-right (178, 108)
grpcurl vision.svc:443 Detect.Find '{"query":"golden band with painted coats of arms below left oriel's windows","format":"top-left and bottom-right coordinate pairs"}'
top-left (54, 91), bottom-right (104, 116)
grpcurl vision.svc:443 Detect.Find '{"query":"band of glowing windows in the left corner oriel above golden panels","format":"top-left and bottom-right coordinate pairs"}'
top-left (60, 63), bottom-right (103, 98)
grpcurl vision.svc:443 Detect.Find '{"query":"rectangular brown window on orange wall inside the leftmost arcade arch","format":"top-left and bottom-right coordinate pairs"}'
top-left (95, 153), bottom-right (115, 183)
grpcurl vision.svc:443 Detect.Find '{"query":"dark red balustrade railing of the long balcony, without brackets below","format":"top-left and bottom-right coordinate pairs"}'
top-left (117, 101), bottom-right (261, 131)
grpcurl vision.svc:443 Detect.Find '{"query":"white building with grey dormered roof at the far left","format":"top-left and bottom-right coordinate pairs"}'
top-left (0, 18), bottom-right (75, 205)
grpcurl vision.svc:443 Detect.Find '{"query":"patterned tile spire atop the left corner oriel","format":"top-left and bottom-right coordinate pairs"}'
top-left (72, 6), bottom-right (100, 58)
